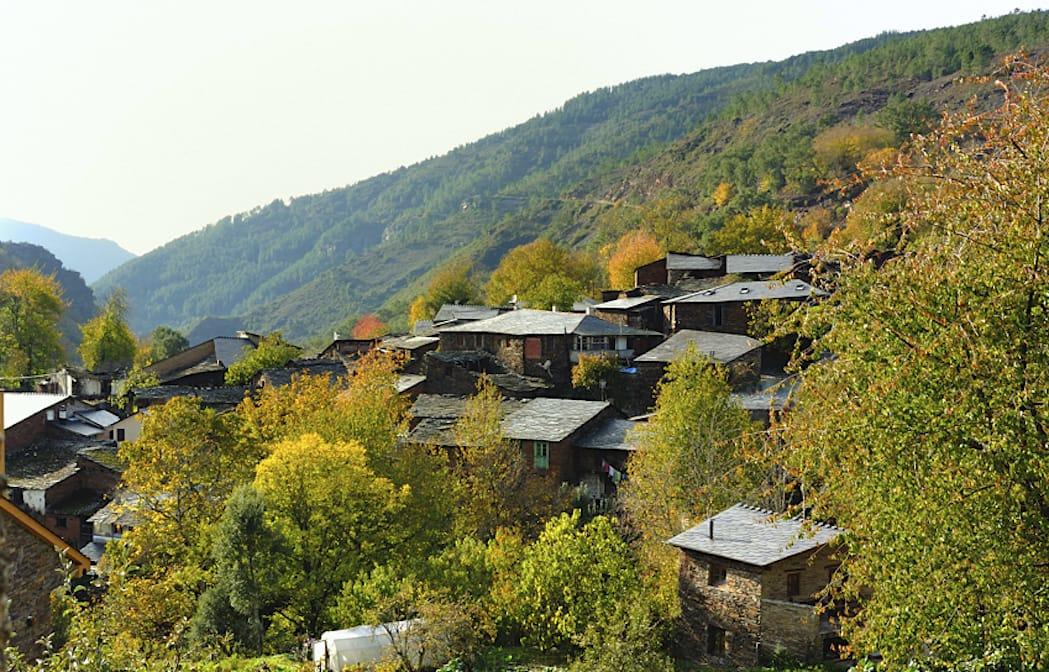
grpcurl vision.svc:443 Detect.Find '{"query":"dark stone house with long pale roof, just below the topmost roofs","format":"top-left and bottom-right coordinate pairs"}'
top-left (663, 280), bottom-right (827, 334)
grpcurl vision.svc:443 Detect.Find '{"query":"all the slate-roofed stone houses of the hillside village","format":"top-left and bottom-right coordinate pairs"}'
top-left (0, 249), bottom-right (840, 665)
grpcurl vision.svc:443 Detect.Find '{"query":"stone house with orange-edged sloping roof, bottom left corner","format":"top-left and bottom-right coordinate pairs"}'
top-left (0, 496), bottom-right (91, 659)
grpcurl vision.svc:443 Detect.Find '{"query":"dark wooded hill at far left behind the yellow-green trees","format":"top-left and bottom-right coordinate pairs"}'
top-left (0, 242), bottom-right (97, 356)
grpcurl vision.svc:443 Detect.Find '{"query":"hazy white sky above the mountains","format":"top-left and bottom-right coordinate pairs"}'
top-left (0, 0), bottom-right (1039, 253)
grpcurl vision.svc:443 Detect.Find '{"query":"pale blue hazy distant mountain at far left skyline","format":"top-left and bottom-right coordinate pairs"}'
top-left (0, 218), bottom-right (135, 284)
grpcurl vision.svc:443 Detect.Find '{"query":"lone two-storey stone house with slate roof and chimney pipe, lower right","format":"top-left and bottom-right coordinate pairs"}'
top-left (667, 504), bottom-right (843, 667)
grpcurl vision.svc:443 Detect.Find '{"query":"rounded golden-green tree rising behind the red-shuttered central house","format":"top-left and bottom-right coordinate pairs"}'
top-left (485, 238), bottom-right (601, 310)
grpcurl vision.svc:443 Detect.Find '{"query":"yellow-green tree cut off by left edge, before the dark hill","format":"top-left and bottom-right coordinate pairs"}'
top-left (0, 268), bottom-right (65, 377)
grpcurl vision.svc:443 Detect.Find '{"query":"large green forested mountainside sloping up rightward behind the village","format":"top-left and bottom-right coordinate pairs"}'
top-left (95, 7), bottom-right (1049, 339)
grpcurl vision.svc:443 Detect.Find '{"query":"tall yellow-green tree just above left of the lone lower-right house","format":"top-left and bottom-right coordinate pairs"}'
top-left (620, 347), bottom-right (756, 611)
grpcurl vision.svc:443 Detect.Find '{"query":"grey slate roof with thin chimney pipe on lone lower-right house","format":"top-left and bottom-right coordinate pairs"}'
top-left (666, 504), bottom-right (844, 567)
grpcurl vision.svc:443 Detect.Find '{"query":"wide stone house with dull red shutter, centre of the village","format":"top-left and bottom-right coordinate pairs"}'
top-left (440, 309), bottom-right (663, 389)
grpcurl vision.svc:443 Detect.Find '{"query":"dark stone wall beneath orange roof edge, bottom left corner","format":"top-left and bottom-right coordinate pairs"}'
top-left (0, 513), bottom-right (62, 658)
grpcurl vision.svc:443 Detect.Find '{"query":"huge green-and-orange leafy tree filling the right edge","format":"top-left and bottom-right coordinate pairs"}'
top-left (782, 65), bottom-right (1049, 670)
